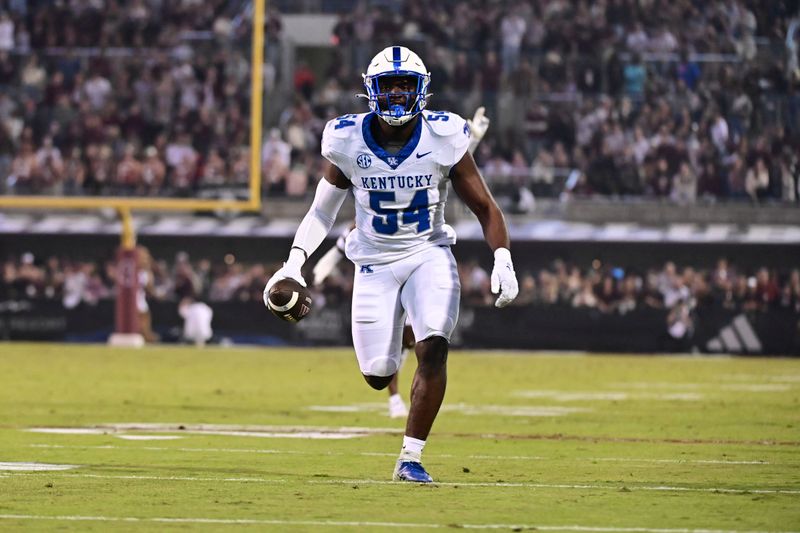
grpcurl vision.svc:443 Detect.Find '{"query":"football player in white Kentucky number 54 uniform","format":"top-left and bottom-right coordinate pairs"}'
top-left (264, 46), bottom-right (518, 483)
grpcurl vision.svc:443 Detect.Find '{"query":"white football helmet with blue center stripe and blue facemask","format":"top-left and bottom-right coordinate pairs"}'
top-left (359, 46), bottom-right (431, 126)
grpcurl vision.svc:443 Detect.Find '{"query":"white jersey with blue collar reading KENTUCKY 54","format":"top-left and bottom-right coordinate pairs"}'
top-left (322, 111), bottom-right (470, 264)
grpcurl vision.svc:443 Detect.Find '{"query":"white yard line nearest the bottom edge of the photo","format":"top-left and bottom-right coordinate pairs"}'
top-left (0, 514), bottom-right (797, 533)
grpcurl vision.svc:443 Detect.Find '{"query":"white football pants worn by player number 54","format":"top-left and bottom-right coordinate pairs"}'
top-left (353, 246), bottom-right (461, 376)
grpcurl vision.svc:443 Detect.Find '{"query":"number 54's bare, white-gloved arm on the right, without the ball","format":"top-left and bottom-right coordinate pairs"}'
top-left (450, 153), bottom-right (519, 307)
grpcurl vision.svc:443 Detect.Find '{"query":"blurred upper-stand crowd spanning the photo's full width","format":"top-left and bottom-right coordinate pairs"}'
top-left (0, 0), bottom-right (800, 202)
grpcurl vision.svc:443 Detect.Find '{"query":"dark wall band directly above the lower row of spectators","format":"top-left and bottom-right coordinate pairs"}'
top-left (0, 234), bottom-right (800, 271)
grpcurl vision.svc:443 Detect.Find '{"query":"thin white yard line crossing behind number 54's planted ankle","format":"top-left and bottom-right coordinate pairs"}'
top-left (30, 444), bottom-right (776, 465)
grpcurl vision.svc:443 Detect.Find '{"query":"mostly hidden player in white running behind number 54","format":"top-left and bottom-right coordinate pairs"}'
top-left (313, 107), bottom-right (490, 418)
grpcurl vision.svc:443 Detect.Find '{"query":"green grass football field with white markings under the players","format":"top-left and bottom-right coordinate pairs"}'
top-left (0, 343), bottom-right (800, 533)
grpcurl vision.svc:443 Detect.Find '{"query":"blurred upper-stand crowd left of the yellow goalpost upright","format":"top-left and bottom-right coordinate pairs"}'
top-left (0, 0), bottom-right (250, 196)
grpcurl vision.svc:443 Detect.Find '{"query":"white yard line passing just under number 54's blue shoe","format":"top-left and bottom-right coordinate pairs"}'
top-left (3, 473), bottom-right (800, 494)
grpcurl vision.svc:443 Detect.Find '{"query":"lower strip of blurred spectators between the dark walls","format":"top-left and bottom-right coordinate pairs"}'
top-left (0, 248), bottom-right (800, 315)
